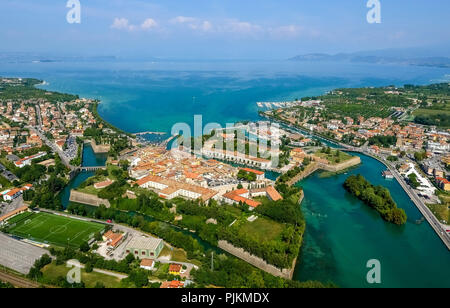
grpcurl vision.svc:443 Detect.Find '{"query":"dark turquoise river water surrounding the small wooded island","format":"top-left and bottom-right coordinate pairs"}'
top-left (294, 155), bottom-right (450, 287)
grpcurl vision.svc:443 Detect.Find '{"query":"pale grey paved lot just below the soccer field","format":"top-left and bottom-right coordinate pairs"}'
top-left (0, 234), bottom-right (47, 274)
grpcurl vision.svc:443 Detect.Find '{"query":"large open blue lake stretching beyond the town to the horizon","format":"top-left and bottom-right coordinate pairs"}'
top-left (0, 61), bottom-right (450, 132)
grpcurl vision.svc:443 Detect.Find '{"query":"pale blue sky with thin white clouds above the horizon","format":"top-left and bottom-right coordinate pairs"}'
top-left (0, 0), bottom-right (450, 59)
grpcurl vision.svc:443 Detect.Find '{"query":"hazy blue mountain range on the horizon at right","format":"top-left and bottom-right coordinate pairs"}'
top-left (289, 52), bottom-right (450, 68)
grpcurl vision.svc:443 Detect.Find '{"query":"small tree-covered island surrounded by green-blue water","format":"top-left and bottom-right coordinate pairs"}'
top-left (344, 174), bottom-right (406, 225)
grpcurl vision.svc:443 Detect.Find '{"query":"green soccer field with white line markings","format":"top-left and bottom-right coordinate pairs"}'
top-left (8, 213), bottom-right (105, 248)
